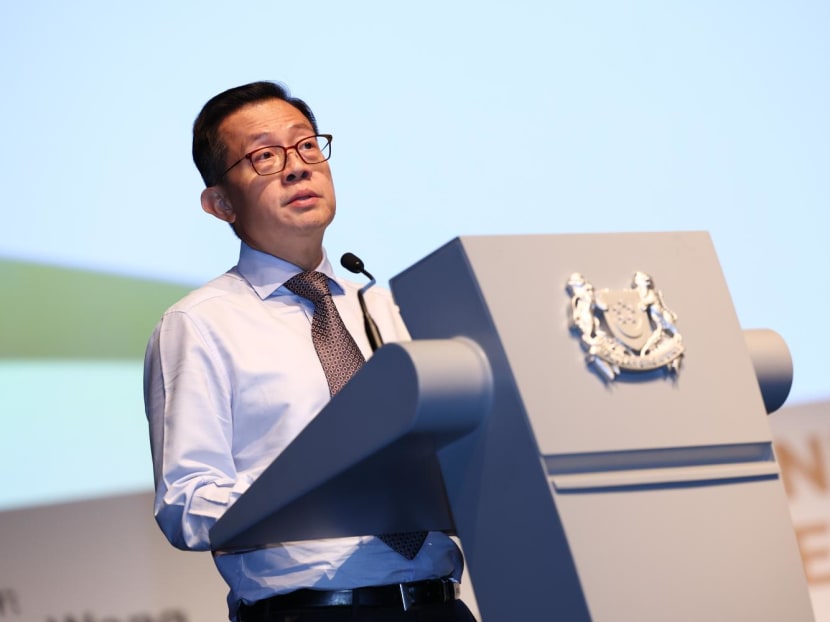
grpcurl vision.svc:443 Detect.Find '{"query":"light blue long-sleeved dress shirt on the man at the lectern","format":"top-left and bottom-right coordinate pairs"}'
top-left (144, 243), bottom-right (463, 619)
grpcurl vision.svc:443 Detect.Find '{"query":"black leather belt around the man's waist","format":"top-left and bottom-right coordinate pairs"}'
top-left (239, 579), bottom-right (459, 622)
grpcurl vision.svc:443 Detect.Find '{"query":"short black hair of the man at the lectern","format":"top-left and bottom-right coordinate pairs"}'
top-left (193, 81), bottom-right (319, 187)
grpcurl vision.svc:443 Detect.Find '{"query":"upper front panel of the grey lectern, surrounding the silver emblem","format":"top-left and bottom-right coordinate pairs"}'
top-left (461, 233), bottom-right (770, 455)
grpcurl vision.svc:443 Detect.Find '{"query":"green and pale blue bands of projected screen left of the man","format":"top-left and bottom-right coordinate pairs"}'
top-left (0, 261), bottom-right (187, 509)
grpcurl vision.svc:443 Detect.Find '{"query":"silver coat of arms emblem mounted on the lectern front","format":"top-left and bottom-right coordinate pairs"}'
top-left (567, 272), bottom-right (684, 380)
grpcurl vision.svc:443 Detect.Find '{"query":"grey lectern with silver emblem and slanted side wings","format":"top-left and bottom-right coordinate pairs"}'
top-left (211, 233), bottom-right (813, 622)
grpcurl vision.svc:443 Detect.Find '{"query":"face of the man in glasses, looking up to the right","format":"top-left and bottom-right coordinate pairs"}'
top-left (202, 99), bottom-right (336, 263)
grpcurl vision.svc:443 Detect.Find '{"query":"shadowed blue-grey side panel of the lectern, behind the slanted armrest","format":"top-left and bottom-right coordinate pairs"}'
top-left (392, 241), bottom-right (589, 622)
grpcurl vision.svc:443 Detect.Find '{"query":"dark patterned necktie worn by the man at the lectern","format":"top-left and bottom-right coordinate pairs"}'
top-left (285, 271), bottom-right (427, 559)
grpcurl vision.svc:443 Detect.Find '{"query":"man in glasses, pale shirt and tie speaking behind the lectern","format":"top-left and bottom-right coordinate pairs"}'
top-left (145, 82), bottom-right (473, 622)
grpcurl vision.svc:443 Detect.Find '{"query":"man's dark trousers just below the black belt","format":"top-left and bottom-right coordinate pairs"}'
top-left (239, 600), bottom-right (476, 622)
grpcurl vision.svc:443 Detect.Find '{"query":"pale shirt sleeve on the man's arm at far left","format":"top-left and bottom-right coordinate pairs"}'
top-left (144, 311), bottom-right (251, 550)
